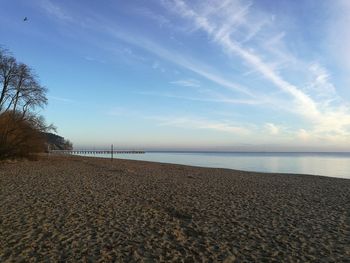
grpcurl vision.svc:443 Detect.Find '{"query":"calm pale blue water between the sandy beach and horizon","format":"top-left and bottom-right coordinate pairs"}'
top-left (77, 152), bottom-right (350, 179)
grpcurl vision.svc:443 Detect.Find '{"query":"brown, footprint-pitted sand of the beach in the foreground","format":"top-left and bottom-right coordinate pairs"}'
top-left (0, 157), bottom-right (350, 262)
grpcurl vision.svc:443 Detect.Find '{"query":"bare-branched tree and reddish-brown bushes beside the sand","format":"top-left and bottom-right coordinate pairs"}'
top-left (0, 48), bottom-right (72, 159)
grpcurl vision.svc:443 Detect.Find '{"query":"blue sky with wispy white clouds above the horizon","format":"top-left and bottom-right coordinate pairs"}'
top-left (0, 0), bottom-right (350, 151)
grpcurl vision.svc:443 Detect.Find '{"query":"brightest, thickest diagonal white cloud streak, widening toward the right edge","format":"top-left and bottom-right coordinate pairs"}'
top-left (163, 0), bottom-right (350, 143)
